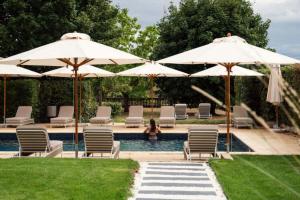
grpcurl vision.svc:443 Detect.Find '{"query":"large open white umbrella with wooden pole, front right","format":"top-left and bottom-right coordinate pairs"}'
top-left (158, 34), bottom-right (300, 151)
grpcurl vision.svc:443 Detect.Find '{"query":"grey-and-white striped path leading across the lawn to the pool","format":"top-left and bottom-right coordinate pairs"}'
top-left (130, 162), bottom-right (226, 200)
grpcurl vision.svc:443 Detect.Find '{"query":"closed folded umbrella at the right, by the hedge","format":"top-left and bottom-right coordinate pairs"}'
top-left (267, 65), bottom-right (283, 128)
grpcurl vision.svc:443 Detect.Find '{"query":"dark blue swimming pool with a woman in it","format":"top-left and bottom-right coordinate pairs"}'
top-left (0, 133), bottom-right (253, 152)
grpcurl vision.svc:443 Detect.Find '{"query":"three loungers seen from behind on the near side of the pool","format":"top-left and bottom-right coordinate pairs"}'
top-left (16, 125), bottom-right (218, 160)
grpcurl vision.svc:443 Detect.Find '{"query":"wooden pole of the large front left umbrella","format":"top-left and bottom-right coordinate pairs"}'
top-left (73, 64), bottom-right (78, 158)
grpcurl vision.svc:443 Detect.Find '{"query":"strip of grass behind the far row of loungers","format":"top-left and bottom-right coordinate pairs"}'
top-left (114, 111), bottom-right (225, 124)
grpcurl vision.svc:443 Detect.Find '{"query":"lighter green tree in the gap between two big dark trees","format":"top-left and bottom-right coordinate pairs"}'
top-left (103, 24), bottom-right (159, 101)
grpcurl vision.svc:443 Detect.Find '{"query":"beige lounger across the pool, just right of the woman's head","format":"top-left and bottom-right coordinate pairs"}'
top-left (159, 106), bottom-right (176, 127)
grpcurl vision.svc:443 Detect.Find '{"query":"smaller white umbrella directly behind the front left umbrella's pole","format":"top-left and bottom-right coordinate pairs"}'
top-left (43, 65), bottom-right (115, 122)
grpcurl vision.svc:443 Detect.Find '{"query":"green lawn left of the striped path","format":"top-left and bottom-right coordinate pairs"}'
top-left (0, 158), bottom-right (138, 200)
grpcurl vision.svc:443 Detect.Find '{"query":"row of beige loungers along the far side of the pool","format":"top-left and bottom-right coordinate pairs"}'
top-left (5, 103), bottom-right (254, 128)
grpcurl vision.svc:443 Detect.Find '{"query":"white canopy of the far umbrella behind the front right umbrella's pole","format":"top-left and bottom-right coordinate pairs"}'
top-left (190, 65), bottom-right (263, 77)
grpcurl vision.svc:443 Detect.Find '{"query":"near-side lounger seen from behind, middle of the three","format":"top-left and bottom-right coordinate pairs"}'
top-left (83, 126), bottom-right (120, 158)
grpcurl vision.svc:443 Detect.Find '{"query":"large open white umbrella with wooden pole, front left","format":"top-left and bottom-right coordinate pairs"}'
top-left (0, 32), bottom-right (145, 158)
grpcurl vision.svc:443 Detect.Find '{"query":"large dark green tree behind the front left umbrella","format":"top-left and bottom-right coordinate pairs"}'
top-left (0, 0), bottom-right (146, 119)
